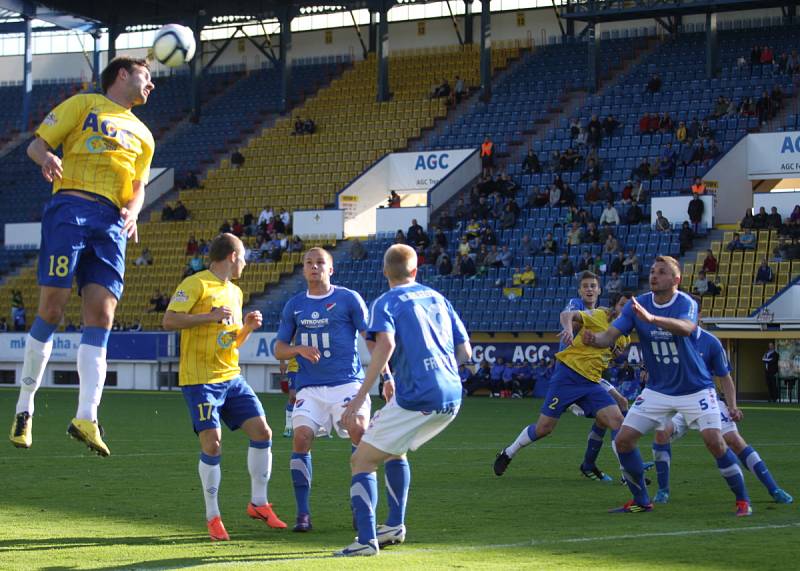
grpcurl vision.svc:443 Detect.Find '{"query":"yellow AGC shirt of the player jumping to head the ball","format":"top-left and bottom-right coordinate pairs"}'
top-left (36, 94), bottom-right (155, 208)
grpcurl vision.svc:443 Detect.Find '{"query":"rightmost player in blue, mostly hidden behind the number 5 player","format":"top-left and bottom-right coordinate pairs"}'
top-left (653, 327), bottom-right (794, 504)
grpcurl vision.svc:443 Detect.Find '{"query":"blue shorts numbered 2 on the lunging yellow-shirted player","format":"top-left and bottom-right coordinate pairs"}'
top-left (541, 362), bottom-right (617, 418)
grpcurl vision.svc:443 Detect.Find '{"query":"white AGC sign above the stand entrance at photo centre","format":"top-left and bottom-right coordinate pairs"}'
top-left (389, 149), bottom-right (475, 192)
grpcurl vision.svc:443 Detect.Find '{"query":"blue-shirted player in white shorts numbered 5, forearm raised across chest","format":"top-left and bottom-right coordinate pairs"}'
top-left (583, 256), bottom-right (752, 516)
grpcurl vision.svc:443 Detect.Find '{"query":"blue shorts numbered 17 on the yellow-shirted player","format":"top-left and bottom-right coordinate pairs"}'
top-left (181, 375), bottom-right (265, 432)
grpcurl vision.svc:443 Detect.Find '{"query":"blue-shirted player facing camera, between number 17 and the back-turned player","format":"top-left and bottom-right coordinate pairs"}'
top-left (275, 248), bottom-right (370, 532)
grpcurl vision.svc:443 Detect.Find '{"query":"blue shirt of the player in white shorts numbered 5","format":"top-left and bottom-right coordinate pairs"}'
top-left (611, 291), bottom-right (714, 396)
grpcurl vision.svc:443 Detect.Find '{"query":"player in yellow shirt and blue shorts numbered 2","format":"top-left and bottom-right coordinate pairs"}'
top-left (494, 286), bottom-right (630, 476)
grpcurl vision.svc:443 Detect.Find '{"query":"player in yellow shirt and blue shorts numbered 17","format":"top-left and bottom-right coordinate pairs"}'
top-left (163, 234), bottom-right (286, 541)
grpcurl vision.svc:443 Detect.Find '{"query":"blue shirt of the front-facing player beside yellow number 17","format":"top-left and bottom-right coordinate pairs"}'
top-left (278, 286), bottom-right (367, 391)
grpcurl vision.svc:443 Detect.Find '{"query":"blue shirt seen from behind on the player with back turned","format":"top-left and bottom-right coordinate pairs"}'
top-left (368, 283), bottom-right (469, 412)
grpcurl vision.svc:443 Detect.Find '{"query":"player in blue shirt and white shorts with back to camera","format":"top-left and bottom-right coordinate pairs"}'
top-left (336, 244), bottom-right (472, 556)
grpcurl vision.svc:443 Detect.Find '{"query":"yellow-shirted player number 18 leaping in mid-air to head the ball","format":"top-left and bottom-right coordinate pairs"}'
top-left (10, 57), bottom-right (155, 456)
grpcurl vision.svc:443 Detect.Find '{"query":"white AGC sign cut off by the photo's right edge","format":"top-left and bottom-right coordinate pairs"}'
top-left (747, 131), bottom-right (800, 180)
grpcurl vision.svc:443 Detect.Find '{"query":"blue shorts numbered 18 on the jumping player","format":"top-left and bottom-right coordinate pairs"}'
top-left (38, 192), bottom-right (128, 299)
